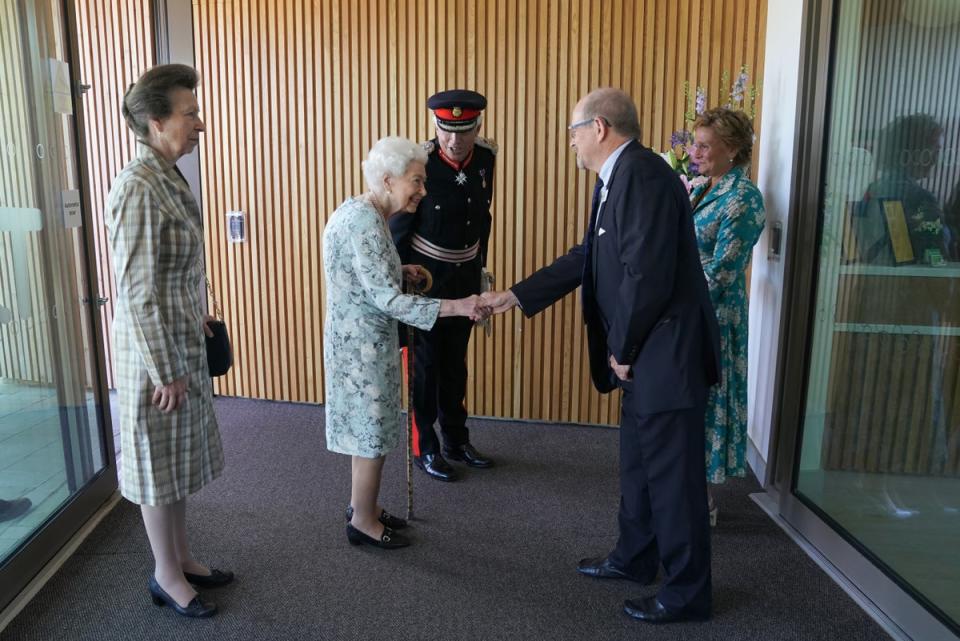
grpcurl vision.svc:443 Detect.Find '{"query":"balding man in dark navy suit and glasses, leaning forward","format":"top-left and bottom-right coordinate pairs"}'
top-left (485, 88), bottom-right (720, 623)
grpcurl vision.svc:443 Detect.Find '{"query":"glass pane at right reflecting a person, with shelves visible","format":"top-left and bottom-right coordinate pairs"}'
top-left (795, 0), bottom-right (960, 629)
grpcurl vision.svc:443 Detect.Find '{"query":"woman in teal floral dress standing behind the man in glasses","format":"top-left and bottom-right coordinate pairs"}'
top-left (690, 107), bottom-right (766, 524)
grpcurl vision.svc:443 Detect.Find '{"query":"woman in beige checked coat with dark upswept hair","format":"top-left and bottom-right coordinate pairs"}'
top-left (106, 65), bottom-right (233, 617)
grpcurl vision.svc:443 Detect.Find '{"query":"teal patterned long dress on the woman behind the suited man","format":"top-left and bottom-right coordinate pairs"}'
top-left (690, 167), bottom-right (766, 483)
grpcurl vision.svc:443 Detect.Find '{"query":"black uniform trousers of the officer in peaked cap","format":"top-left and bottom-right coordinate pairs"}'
top-left (413, 318), bottom-right (473, 456)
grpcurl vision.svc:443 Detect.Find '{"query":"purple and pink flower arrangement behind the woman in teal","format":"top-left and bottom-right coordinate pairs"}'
top-left (660, 65), bottom-right (759, 193)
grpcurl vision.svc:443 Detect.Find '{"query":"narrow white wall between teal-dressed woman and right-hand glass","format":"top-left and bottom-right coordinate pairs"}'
top-left (747, 0), bottom-right (804, 482)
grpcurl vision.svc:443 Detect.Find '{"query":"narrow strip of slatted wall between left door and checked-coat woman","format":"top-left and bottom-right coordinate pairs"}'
top-left (75, 0), bottom-right (156, 388)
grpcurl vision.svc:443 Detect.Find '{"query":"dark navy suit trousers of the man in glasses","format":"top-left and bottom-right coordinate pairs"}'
top-left (611, 385), bottom-right (711, 615)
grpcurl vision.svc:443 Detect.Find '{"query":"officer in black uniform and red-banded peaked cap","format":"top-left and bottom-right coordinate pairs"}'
top-left (390, 90), bottom-right (496, 481)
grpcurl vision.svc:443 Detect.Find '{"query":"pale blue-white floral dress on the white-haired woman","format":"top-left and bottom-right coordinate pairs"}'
top-left (323, 198), bottom-right (440, 458)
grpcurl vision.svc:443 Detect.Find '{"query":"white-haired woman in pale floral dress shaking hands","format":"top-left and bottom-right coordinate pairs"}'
top-left (323, 138), bottom-right (486, 548)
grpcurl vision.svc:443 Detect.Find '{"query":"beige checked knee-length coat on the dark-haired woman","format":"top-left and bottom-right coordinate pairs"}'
top-left (105, 143), bottom-right (223, 505)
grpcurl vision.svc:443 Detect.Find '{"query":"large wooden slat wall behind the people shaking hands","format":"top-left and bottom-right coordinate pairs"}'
top-left (193, 0), bottom-right (766, 424)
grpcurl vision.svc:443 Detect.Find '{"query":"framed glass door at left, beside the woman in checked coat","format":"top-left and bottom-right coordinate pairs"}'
top-left (0, 0), bottom-right (116, 608)
